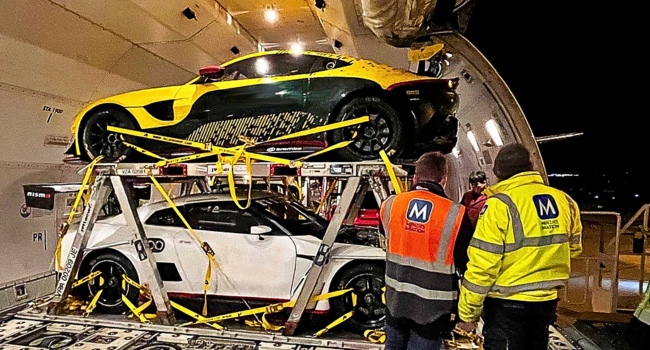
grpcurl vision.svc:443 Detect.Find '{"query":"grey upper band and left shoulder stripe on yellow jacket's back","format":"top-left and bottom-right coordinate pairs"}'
top-left (492, 193), bottom-right (569, 253)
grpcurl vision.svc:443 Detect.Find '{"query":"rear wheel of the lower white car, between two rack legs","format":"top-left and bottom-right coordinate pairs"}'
top-left (77, 252), bottom-right (140, 314)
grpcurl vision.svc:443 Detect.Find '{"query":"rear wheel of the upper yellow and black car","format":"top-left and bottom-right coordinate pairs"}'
top-left (330, 96), bottom-right (406, 161)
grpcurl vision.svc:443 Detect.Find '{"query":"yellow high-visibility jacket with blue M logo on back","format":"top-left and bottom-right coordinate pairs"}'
top-left (458, 171), bottom-right (582, 321)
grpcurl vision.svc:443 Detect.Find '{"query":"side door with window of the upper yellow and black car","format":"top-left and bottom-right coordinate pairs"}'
top-left (168, 54), bottom-right (313, 146)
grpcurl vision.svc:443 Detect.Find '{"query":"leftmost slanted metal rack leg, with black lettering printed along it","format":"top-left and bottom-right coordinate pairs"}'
top-left (47, 176), bottom-right (110, 315)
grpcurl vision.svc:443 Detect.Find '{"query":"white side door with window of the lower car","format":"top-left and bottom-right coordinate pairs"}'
top-left (174, 201), bottom-right (296, 300)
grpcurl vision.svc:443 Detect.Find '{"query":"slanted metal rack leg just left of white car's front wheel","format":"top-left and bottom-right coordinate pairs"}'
top-left (283, 176), bottom-right (361, 336)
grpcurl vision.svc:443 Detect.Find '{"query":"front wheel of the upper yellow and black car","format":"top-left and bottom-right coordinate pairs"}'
top-left (81, 109), bottom-right (137, 162)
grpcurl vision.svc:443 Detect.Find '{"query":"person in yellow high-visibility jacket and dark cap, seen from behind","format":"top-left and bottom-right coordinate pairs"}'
top-left (458, 144), bottom-right (582, 350)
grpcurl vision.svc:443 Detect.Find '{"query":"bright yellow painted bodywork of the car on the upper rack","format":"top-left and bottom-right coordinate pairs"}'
top-left (71, 51), bottom-right (430, 155)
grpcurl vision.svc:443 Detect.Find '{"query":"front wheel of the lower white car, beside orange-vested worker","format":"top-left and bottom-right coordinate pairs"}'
top-left (330, 263), bottom-right (386, 334)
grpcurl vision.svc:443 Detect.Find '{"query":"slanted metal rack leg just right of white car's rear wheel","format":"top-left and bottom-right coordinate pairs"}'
top-left (110, 176), bottom-right (176, 325)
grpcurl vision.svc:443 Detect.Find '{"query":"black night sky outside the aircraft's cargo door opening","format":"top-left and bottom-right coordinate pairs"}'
top-left (465, 0), bottom-right (636, 209)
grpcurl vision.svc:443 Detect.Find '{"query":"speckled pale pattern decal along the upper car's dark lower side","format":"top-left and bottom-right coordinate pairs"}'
top-left (187, 111), bottom-right (325, 146)
